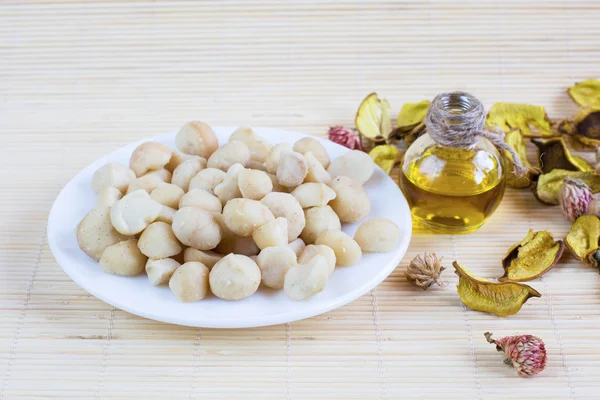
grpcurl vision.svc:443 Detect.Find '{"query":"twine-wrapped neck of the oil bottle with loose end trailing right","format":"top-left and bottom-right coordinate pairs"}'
top-left (425, 92), bottom-right (528, 176)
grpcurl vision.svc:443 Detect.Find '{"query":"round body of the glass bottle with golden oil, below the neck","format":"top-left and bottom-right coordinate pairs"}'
top-left (399, 145), bottom-right (505, 233)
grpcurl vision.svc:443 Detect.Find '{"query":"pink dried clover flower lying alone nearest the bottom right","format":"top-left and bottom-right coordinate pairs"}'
top-left (485, 332), bottom-right (548, 377)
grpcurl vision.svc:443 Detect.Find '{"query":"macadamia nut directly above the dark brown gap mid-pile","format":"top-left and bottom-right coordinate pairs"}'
top-left (223, 199), bottom-right (275, 238)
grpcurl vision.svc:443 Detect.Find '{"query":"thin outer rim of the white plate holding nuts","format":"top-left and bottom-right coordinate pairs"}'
top-left (46, 125), bottom-right (413, 329)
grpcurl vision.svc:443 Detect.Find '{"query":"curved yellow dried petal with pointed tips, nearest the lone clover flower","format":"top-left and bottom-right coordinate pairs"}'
top-left (452, 261), bottom-right (542, 317)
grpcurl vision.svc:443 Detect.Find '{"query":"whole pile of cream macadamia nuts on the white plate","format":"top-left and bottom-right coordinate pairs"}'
top-left (77, 122), bottom-right (400, 302)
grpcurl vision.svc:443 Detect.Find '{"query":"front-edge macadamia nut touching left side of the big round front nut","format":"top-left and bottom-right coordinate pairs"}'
top-left (169, 262), bottom-right (209, 303)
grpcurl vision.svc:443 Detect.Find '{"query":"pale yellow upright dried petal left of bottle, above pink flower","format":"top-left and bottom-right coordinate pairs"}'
top-left (355, 93), bottom-right (392, 143)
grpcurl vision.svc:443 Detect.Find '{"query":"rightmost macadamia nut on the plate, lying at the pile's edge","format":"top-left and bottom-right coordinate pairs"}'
top-left (354, 218), bottom-right (400, 253)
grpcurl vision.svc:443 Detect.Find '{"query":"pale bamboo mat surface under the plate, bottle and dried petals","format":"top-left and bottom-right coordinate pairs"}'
top-left (0, 0), bottom-right (600, 400)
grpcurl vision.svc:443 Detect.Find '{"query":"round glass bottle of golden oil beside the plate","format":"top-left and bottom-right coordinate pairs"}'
top-left (399, 92), bottom-right (505, 234)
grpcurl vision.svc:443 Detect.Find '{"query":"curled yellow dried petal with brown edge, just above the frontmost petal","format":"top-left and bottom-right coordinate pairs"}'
top-left (498, 229), bottom-right (564, 282)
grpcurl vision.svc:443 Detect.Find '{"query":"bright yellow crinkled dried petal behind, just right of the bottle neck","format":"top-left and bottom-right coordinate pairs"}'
top-left (486, 103), bottom-right (554, 137)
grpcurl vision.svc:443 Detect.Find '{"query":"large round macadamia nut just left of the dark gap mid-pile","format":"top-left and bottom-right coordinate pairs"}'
top-left (173, 207), bottom-right (221, 250)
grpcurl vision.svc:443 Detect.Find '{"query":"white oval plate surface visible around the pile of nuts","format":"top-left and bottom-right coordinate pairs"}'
top-left (48, 127), bottom-right (412, 328)
